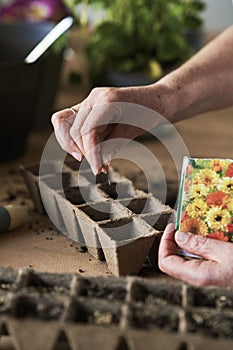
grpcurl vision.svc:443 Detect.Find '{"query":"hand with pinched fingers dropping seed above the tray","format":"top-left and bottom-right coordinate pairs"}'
top-left (52, 83), bottom-right (170, 174)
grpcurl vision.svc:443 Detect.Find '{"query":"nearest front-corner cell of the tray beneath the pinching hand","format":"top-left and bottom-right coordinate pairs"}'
top-left (99, 217), bottom-right (158, 276)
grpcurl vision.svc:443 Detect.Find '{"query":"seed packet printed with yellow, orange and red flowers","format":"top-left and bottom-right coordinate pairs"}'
top-left (176, 157), bottom-right (233, 259)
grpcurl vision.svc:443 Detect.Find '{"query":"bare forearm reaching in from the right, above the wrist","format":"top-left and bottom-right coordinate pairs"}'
top-left (156, 26), bottom-right (233, 122)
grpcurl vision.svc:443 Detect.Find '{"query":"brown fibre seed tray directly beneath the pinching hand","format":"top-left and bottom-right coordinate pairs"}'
top-left (21, 160), bottom-right (175, 276)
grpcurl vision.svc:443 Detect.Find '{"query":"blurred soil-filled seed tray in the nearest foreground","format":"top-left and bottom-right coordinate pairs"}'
top-left (0, 267), bottom-right (233, 350)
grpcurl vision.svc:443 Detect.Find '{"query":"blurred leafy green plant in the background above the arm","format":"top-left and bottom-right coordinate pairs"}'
top-left (66, 0), bottom-right (204, 84)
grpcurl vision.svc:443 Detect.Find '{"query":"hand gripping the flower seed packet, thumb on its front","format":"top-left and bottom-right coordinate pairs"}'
top-left (159, 224), bottom-right (233, 286)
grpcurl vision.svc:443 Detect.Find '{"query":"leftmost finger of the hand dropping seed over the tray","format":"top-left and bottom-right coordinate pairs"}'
top-left (52, 108), bottom-right (82, 160)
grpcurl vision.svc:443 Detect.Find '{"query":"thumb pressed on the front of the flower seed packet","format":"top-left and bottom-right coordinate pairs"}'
top-left (175, 231), bottom-right (232, 261)
